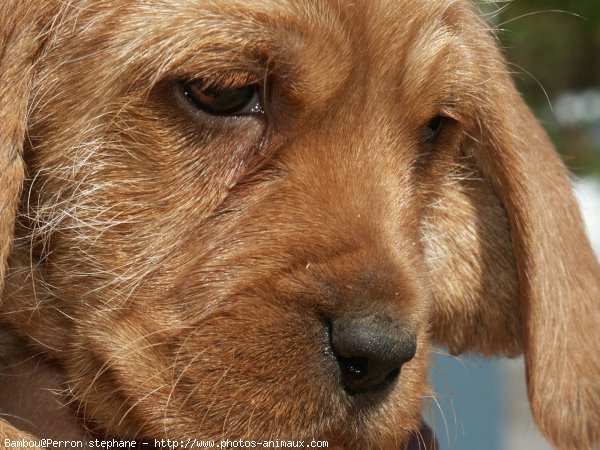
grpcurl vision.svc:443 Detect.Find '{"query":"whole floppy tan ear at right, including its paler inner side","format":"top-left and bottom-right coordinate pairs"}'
top-left (425, 14), bottom-right (600, 449)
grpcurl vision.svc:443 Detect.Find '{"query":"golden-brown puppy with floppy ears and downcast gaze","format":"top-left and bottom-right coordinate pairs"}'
top-left (0, 0), bottom-right (600, 449)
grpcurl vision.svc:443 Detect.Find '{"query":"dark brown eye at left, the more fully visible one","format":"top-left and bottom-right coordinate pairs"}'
top-left (183, 81), bottom-right (264, 116)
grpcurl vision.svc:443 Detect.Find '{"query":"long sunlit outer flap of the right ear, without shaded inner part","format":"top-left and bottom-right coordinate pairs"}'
top-left (475, 82), bottom-right (600, 449)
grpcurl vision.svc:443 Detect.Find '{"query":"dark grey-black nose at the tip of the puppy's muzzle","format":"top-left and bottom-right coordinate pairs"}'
top-left (330, 316), bottom-right (417, 395)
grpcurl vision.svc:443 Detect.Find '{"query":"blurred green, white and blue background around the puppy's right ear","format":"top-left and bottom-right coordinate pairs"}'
top-left (425, 0), bottom-right (600, 450)
